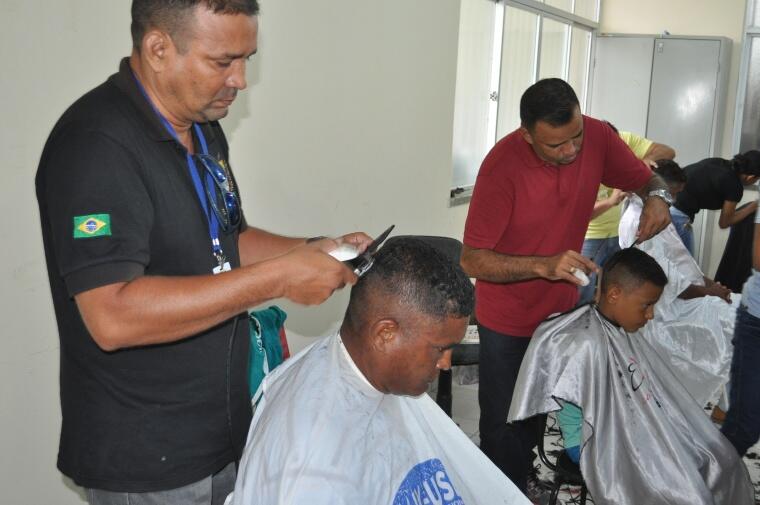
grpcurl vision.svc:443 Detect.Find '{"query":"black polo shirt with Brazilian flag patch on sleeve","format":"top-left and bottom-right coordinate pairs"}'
top-left (36, 59), bottom-right (251, 492)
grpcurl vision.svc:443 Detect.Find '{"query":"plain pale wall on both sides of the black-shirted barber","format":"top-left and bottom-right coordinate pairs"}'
top-left (0, 0), bottom-right (466, 505)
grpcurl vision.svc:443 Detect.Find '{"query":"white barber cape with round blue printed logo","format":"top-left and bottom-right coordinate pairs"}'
top-left (228, 335), bottom-right (530, 505)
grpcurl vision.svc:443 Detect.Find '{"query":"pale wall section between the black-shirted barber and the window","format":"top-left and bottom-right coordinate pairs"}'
top-left (232, 0), bottom-right (467, 335)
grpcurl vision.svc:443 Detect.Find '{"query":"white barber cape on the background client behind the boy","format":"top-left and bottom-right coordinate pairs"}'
top-left (618, 195), bottom-right (741, 406)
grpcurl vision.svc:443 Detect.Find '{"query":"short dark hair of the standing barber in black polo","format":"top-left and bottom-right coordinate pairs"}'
top-left (131, 0), bottom-right (259, 52)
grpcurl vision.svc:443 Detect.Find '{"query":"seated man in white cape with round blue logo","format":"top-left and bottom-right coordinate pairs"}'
top-left (231, 238), bottom-right (530, 505)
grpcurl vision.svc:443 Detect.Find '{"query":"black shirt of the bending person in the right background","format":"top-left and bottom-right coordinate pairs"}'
top-left (675, 158), bottom-right (744, 221)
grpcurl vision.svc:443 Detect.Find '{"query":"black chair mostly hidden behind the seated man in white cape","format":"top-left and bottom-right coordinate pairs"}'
top-left (386, 235), bottom-right (480, 417)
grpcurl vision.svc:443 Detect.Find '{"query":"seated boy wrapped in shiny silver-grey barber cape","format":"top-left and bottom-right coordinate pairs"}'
top-left (509, 248), bottom-right (754, 505)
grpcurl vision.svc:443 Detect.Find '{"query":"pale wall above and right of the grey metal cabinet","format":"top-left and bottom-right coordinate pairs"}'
top-left (599, 0), bottom-right (757, 276)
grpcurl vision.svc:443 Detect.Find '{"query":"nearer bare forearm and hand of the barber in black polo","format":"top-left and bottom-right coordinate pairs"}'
top-left (75, 243), bottom-right (356, 350)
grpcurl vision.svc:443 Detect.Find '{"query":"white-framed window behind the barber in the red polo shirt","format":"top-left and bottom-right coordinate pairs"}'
top-left (451, 0), bottom-right (600, 203)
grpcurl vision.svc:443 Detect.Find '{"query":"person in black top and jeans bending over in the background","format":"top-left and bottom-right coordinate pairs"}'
top-left (670, 151), bottom-right (760, 254)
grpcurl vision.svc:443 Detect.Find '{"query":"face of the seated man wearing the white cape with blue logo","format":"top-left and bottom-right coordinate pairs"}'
top-left (379, 314), bottom-right (468, 396)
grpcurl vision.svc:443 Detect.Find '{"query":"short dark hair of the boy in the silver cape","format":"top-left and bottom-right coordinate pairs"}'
top-left (601, 247), bottom-right (668, 293)
